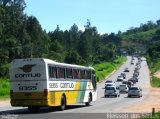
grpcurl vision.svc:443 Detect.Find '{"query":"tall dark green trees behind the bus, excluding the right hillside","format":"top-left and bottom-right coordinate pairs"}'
top-left (0, 0), bottom-right (121, 77)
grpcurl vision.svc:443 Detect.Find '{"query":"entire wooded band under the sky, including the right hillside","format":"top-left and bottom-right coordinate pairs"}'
top-left (0, 0), bottom-right (160, 77)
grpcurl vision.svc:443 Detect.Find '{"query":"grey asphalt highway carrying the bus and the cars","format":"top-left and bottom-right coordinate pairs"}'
top-left (0, 57), bottom-right (150, 119)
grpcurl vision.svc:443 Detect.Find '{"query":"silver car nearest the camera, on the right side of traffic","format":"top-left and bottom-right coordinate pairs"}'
top-left (128, 87), bottom-right (142, 97)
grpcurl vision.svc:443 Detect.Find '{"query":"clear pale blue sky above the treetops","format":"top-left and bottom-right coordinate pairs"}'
top-left (24, 0), bottom-right (160, 34)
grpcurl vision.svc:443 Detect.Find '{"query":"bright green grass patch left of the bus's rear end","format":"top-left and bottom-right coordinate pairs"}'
top-left (0, 78), bottom-right (10, 99)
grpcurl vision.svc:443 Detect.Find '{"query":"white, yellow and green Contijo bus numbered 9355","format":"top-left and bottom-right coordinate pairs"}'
top-left (10, 58), bottom-right (97, 111)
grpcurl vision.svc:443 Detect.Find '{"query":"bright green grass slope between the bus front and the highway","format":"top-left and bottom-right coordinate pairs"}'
top-left (93, 57), bottom-right (126, 82)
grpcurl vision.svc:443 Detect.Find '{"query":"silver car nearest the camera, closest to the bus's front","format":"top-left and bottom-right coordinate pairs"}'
top-left (104, 86), bottom-right (120, 97)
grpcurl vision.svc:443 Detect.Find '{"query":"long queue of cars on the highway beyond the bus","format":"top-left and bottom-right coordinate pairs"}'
top-left (104, 57), bottom-right (142, 97)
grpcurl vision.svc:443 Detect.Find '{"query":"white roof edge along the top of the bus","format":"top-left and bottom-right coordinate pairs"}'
top-left (12, 58), bottom-right (94, 70)
